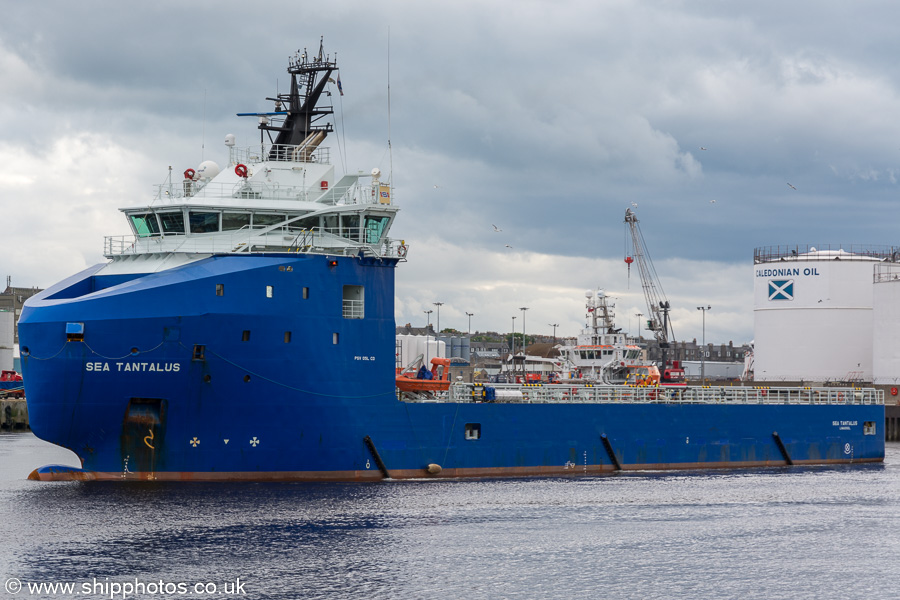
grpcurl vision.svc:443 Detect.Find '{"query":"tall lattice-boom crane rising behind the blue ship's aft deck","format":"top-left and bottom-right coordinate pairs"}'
top-left (625, 208), bottom-right (684, 384)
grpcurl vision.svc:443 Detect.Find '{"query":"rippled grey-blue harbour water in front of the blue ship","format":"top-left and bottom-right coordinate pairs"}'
top-left (0, 434), bottom-right (900, 600)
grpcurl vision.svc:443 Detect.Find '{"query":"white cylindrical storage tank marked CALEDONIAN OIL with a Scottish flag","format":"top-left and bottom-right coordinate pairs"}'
top-left (753, 246), bottom-right (893, 384)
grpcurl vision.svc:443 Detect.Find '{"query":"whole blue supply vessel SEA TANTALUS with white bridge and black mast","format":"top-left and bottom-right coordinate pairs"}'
top-left (19, 45), bottom-right (884, 480)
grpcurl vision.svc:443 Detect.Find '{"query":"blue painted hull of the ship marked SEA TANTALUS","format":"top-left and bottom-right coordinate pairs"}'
top-left (19, 255), bottom-right (884, 480)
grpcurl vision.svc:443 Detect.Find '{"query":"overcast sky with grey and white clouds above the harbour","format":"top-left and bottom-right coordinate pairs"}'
top-left (0, 0), bottom-right (900, 344)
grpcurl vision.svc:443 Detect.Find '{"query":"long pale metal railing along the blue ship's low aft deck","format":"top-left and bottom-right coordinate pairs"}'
top-left (431, 382), bottom-right (884, 405)
